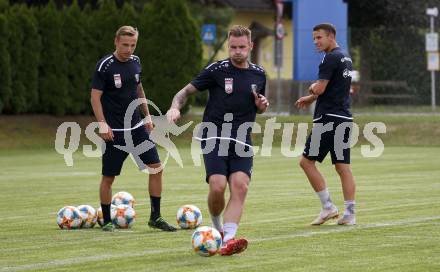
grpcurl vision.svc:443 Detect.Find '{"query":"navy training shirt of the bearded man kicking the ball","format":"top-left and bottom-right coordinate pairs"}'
top-left (191, 59), bottom-right (266, 137)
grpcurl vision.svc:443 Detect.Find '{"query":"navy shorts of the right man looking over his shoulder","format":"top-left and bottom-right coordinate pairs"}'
top-left (303, 115), bottom-right (353, 164)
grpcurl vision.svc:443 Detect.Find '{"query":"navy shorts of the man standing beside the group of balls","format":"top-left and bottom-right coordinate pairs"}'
top-left (102, 126), bottom-right (160, 176)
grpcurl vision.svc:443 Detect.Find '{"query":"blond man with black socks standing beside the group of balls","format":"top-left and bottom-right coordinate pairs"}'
top-left (91, 26), bottom-right (176, 231)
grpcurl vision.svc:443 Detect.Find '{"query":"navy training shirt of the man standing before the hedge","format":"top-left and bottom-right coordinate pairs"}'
top-left (92, 54), bottom-right (142, 129)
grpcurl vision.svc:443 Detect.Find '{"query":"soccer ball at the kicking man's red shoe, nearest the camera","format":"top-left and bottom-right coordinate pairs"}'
top-left (191, 226), bottom-right (222, 257)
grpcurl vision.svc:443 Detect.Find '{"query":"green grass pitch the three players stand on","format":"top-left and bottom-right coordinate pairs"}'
top-left (0, 146), bottom-right (440, 272)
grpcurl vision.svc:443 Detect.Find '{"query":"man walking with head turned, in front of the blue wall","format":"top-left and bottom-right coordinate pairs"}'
top-left (296, 23), bottom-right (356, 225)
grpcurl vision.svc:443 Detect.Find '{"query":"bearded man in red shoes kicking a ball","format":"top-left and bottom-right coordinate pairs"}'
top-left (167, 26), bottom-right (269, 255)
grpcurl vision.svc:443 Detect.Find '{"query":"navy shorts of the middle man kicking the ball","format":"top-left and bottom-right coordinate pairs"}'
top-left (201, 139), bottom-right (253, 182)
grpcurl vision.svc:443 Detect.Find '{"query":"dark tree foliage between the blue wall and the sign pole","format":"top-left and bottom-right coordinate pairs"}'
top-left (348, 0), bottom-right (438, 103)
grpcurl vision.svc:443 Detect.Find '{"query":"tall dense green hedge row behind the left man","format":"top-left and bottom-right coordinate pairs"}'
top-left (0, 0), bottom-right (202, 115)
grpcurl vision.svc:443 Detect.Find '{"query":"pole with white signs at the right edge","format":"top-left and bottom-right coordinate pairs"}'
top-left (426, 7), bottom-right (439, 111)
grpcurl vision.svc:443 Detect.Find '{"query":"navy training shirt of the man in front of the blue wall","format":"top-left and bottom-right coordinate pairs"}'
top-left (313, 47), bottom-right (353, 119)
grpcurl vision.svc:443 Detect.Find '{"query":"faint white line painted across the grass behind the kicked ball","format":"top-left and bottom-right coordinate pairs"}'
top-left (0, 216), bottom-right (440, 271)
